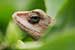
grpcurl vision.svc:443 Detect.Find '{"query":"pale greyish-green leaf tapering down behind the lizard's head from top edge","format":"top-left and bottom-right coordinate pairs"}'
top-left (45, 0), bottom-right (67, 17)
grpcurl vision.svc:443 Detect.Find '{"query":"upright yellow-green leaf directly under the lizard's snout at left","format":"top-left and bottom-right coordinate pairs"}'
top-left (5, 21), bottom-right (25, 45)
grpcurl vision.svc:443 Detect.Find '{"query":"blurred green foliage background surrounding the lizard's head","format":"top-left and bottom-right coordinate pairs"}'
top-left (0, 0), bottom-right (75, 50)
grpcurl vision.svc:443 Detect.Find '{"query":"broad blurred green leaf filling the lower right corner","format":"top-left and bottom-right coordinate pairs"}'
top-left (37, 28), bottom-right (75, 50)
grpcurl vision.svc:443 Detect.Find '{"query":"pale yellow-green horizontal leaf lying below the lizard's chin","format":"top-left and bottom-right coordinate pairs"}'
top-left (16, 40), bottom-right (43, 50)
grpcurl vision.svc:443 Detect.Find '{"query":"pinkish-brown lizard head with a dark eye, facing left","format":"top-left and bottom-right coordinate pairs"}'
top-left (12, 9), bottom-right (52, 40)
